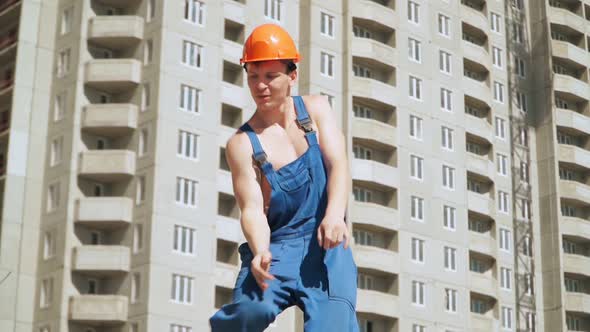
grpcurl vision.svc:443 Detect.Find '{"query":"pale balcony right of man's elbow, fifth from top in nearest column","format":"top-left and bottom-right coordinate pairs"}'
top-left (351, 158), bottom-right (399, 189)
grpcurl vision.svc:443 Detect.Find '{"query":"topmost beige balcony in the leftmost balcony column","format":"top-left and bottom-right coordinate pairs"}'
top-left (88, 15), bottom-right (143, 49)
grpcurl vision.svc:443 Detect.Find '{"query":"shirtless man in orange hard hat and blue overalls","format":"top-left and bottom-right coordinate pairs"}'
top-left (210, 24), bottom-right (358, 332)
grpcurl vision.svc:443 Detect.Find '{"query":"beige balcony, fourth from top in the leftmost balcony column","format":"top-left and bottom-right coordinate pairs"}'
top-left (79, 150), bottom-right (135, 182)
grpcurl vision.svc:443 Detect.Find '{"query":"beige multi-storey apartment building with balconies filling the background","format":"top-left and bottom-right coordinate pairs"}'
top-left (0, 0), bottom-right (590, 332)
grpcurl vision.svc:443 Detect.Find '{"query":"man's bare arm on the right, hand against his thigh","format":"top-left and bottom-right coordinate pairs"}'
top-left (310, 96), bottom-right (350, 249)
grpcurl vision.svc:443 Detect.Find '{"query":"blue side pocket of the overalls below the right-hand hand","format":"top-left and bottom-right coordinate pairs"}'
top-left (324, 243), bottom-right (357, 310)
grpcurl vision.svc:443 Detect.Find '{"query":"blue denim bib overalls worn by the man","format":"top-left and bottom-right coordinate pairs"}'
top-left (210, 96), bottom-right (358, 332)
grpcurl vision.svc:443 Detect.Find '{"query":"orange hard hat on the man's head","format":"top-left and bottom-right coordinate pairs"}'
top-left (240, 23), bottom-right (300, 64)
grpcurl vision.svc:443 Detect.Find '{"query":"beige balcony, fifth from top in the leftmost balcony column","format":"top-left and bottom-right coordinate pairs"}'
top-left (75, 197), bottom-right (133, 229)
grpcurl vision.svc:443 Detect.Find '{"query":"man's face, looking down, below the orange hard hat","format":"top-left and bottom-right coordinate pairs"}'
top-left (247, 60), bottom-right (297, 109)
